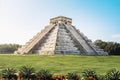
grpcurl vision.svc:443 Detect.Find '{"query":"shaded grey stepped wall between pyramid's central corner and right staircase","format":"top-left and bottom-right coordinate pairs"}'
top-left (55, 23), bottom-right (80, 54)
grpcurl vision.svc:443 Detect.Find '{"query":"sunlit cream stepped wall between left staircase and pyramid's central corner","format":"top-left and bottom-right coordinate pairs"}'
top-left (35, 25), bottom-right (58, 54)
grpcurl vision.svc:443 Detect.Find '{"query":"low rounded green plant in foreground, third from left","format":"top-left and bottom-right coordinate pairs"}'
top-left (36, 70), bottom-right (52, 80)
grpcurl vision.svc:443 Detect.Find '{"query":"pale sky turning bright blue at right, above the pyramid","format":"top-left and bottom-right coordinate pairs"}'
top-left (0, 0), bottom-right (120, 44)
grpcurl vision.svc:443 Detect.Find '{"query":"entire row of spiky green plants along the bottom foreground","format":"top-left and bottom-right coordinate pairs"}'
top-left (0, 66), bottom-right (120, 80)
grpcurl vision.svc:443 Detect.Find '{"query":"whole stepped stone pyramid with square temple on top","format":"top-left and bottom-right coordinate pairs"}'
top-left (15, 16), bottom-right (108, 55)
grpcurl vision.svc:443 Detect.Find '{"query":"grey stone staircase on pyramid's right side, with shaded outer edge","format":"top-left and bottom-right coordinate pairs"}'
top-left (67, 25), bottom-right (108, 55)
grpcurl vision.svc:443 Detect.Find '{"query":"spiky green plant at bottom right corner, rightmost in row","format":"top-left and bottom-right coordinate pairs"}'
top-left (106, 69), bottom-right (120, 80)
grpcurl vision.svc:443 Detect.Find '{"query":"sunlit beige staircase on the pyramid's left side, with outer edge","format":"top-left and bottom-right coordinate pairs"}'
top-left (15, 24), bottom-right (55, 54)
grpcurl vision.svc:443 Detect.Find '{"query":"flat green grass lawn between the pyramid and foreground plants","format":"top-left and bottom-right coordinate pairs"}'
top-left (0, 55), bottom-right (120, 74)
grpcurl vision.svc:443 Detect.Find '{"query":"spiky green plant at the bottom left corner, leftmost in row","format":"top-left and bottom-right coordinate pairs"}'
top-left (2, 68), bottom-right (17, 80)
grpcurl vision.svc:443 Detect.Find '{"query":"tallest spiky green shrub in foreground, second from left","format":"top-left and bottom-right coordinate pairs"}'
top-left (20, 66), bottom-right (35, 80)
